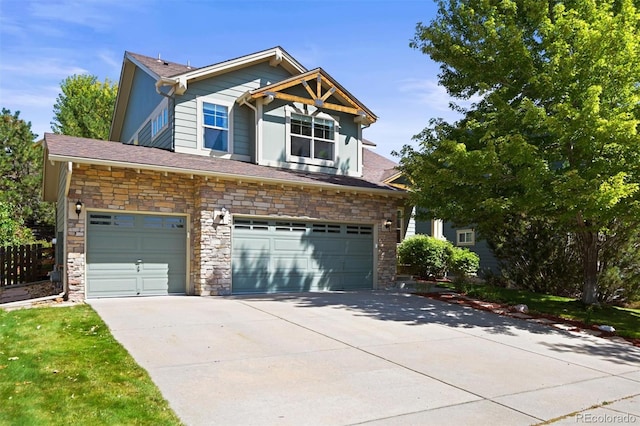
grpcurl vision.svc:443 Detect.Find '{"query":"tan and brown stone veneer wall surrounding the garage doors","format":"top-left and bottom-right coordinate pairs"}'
top-left (66, 165), bottom-right (403, 300)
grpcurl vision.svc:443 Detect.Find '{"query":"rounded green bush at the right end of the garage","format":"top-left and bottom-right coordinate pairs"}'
top-left (398, 235), bottom-right (480, 278)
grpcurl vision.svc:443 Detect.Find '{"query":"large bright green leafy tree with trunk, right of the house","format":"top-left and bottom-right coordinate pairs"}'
top-left (401, 0), bottom-right (640, 304)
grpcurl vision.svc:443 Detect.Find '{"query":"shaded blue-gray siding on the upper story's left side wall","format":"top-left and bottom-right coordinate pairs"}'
top-left (120, 68), bottom-right (163, 142)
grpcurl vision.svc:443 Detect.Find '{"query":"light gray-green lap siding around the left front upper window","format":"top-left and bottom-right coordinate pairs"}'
top-left (175, 63), bottom-right (291, 155)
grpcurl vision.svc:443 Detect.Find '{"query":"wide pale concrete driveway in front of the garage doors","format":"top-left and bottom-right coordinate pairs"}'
top-left (90, 292), bottom-right (640, 425)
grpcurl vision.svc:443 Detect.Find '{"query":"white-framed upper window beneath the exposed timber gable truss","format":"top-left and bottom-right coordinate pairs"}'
top-left (290, 113), bottom-right (337, 161)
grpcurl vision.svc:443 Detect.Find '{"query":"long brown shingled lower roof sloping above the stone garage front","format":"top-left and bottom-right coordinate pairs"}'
top-left (44, 133), bottom-right (397, 192)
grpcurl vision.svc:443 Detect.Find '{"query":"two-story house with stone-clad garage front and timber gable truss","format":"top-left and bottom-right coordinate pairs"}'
top-left (43, 47), bottom-right (406, 300)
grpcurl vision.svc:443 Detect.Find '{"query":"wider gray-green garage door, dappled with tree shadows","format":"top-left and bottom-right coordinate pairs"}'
top-left (231, 218), bottom-right (373, 294)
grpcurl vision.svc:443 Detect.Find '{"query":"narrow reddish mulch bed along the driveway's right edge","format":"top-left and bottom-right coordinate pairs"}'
top-left (415, 292), bottom-right (640, 347)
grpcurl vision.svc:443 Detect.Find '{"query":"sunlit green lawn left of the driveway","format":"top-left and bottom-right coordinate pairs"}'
top-left (0, 305), bottom-right (181, 425)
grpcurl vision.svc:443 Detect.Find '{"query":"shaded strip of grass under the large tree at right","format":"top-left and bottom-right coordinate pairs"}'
top-left (440, 284), bottom-right (640, 339)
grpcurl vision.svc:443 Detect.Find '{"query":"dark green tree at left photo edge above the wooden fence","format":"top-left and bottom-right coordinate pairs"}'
top-left (0, 108), bottom-right (44, 245)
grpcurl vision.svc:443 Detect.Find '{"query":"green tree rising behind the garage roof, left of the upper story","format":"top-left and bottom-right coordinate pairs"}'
top-left (51, 74), bottom-right (118, 140)
